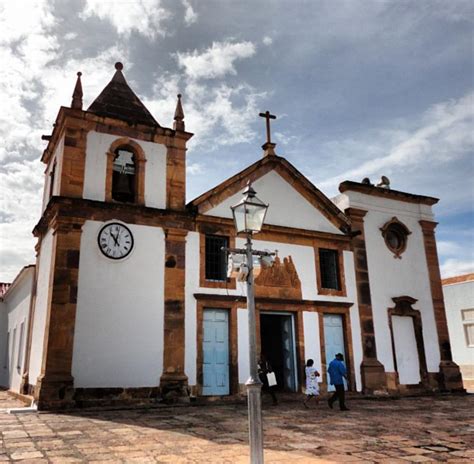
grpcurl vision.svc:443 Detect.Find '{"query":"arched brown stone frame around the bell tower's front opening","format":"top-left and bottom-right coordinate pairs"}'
top-left (105, 137), bottom-right (146, 205)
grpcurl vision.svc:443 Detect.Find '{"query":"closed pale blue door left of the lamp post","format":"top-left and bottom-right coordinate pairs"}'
top-left (202, 309), bottom-right (229, 395)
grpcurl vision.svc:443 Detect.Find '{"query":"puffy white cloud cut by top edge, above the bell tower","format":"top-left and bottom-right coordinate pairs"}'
top-left (81, 0), bottom-right (171, 39)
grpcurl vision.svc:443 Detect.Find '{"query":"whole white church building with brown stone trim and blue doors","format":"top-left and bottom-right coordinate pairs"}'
top-left (0, 63), bottom-right (462, 409)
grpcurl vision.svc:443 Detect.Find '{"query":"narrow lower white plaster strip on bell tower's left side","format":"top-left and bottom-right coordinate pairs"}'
top-left (28, 230), bottom-right (53, 385)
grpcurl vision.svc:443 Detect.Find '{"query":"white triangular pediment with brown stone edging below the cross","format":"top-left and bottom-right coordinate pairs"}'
top-left (190, 155), bottom-right (350, 234)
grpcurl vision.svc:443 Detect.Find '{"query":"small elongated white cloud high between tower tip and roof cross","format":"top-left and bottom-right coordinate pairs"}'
top-left (176, 42), bottom-right (256, 79)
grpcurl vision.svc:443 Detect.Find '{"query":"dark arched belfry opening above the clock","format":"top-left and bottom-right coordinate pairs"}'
top-left (112, 147), bottom-right (137, 203)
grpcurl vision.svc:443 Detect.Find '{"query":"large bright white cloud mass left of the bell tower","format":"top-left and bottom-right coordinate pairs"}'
top-left (0, 0), bottom-right (131, 280)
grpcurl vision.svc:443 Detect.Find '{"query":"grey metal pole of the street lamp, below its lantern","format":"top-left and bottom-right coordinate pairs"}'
top-left (245, 234), bottom-right (263, 464)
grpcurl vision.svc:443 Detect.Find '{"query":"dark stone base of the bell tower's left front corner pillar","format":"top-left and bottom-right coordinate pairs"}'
top-left (34, 375), bottom-right (75, 411)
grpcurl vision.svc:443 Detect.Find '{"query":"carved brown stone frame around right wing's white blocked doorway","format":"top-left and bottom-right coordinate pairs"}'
top-left (388, 296), bottom-right (429, 387)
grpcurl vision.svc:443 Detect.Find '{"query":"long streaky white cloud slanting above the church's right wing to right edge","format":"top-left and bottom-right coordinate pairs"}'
top-left (320, 93), bottom-right (474, 188)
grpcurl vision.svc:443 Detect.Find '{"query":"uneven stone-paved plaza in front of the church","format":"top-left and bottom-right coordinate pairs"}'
top-left (0, 392), bottom-right (474, 464)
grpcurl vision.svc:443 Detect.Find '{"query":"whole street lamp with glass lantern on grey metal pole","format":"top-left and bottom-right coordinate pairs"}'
top-left (231, 182), bottom-right (268, 464)
